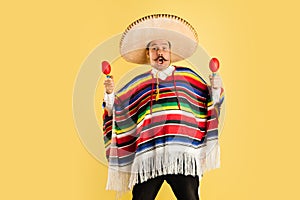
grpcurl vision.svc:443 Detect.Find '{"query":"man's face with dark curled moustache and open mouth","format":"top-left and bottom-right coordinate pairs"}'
top-left (147, 40), bottom-right (171, 70)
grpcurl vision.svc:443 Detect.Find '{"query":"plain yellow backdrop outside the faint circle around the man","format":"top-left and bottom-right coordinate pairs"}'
top-left (0, 0), bottom-right (300, 200)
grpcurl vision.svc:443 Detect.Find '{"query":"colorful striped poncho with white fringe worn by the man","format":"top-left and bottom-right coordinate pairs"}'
top-left (103, 67), bottom-right (223, 191)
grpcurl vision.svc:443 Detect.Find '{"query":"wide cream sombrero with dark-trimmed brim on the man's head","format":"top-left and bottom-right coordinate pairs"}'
top-left (120, 14), bottom-right (198, 64)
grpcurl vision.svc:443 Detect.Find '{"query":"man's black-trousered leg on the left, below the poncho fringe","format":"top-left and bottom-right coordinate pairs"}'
top-left (132, 176), bottom-right (164, 200)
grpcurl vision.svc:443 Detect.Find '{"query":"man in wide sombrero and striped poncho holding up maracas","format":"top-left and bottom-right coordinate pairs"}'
top-left (103, 14), bottom-right (223, 200)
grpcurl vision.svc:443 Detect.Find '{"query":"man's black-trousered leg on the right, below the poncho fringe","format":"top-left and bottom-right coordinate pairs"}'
top-left (166, 174), bottom-right (199, 200)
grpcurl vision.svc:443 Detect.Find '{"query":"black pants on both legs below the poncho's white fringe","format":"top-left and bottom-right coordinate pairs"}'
top-left (132, 174), bottom-right (199, 200)
